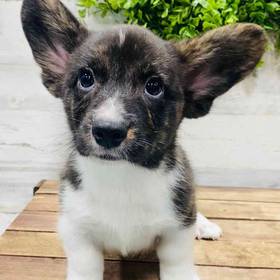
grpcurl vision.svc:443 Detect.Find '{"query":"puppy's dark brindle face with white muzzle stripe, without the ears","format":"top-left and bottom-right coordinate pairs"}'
top-left (62, 26), bottom-right (184, 165)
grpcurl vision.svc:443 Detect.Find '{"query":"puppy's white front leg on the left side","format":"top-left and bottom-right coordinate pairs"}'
top-left (59, 215), bottom-right (104, 280)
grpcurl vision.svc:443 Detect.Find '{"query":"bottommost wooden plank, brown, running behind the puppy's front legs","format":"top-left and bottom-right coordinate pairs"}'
top-left (0, 256), bottom-right (280, 280)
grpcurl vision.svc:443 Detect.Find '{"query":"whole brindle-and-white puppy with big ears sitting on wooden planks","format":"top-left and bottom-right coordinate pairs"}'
top-left (22, 0), bottom-right (265, 280)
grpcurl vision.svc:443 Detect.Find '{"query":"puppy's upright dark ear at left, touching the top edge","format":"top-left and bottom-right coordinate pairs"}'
top-left (21, 0), bottom-right (88, 97)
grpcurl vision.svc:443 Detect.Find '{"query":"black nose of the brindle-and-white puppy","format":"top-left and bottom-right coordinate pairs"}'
top-left (92, 126), bottom-right (127, 149)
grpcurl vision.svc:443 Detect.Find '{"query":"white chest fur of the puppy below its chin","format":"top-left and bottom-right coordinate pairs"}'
top-left (60, 157), bottom-right (178, 255)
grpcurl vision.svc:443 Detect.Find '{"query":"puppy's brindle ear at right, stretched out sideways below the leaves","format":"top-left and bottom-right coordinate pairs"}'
top-left (175, 24), bottom-right (266, 118)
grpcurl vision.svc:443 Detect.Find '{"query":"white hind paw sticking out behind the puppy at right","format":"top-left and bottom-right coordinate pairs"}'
top-left (195, 213), bottom-right (223, 240)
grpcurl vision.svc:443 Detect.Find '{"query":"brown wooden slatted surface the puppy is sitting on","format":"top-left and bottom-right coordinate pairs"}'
top-left (0, 181), bottom-right (280, 280)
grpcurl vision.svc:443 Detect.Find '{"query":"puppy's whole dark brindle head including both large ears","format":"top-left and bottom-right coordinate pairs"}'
top-left (22, 0), bottom-right (265, 167)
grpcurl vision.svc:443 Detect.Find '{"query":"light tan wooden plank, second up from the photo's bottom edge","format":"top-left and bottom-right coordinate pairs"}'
top-left (0, 231), bottom-right (280, 268)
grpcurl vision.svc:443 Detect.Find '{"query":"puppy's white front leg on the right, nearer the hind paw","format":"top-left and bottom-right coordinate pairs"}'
top-left (157, 226), bottom-right (199, 280)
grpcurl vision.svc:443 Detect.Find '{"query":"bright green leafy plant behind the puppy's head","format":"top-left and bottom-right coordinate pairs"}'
top-left (78, 0), bottom-right (280, 49)
